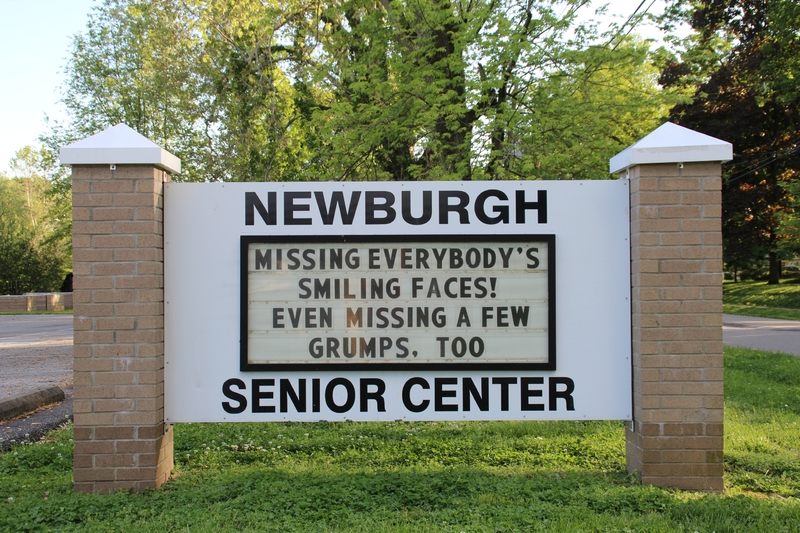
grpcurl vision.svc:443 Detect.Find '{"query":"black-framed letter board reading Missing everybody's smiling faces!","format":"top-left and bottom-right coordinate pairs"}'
top-left (241, 235), bottom-right (555, 371)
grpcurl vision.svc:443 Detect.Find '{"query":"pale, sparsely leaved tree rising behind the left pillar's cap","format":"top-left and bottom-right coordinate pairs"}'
top-left (53, 0), bottom-right (216, 180)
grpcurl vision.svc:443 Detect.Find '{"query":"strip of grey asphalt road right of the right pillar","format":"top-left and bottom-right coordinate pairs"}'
top-left (722, 315), bottom-right (800, 357)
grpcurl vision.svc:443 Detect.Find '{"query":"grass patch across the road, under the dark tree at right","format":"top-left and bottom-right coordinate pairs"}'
top-left (722, 279), bottom-right (800, 320)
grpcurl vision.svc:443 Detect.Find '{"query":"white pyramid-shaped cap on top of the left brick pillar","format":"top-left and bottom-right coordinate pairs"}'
top-left (61, 124), bottom-right (181, 174)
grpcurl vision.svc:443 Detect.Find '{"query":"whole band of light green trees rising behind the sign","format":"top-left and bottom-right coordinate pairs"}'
top-left (46, 0), bottom-right (678, 181)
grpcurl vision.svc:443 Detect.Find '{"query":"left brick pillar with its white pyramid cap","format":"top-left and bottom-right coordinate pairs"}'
top-left (61, 124), bottom-right (180, 493)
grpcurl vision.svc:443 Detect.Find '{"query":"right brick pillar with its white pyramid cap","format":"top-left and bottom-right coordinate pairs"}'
top-left (611, 123), bottom-right (732, 492)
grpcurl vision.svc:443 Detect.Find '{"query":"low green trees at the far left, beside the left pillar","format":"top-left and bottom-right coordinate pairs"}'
top-left (0, 146), bottom-right (72, 294)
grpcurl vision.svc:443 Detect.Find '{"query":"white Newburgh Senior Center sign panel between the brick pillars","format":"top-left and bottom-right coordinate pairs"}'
top-left (164, 180), bottom-right (631, 422)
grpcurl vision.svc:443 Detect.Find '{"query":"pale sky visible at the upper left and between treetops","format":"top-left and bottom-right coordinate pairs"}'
top-left (0, 0), bottom-right (664, 173)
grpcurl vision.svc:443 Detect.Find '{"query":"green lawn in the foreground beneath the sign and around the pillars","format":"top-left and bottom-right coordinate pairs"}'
top-left (0, 348), bottom-right (800, 533)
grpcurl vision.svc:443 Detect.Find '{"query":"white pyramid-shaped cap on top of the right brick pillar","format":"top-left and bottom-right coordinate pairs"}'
top-left (609, 122), bottom-right (733, 174)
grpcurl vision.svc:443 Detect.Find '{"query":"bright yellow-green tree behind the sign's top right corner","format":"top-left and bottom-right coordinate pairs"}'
top-left (504, 39), bottom-right (682, 179)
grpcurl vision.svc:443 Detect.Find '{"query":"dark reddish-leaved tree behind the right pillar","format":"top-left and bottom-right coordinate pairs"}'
top-left (662, 0), bottom-right (800, 283)
